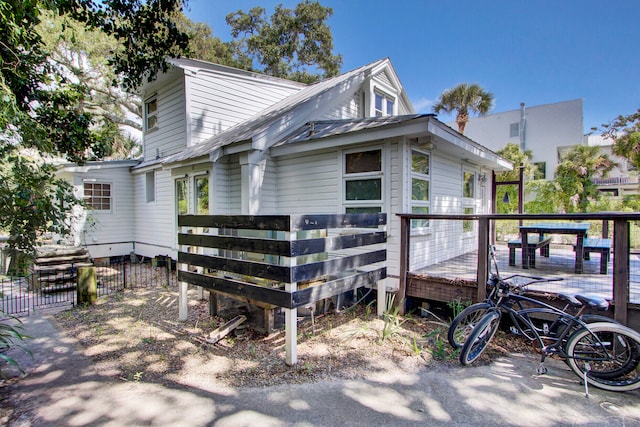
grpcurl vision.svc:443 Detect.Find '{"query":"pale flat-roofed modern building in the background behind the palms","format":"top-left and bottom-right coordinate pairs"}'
top-left (465, 99), bottom-right (584, 179)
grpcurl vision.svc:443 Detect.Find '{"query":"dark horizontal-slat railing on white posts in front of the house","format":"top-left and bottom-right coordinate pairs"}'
top-left (178, 214), bottom-right (387, 364)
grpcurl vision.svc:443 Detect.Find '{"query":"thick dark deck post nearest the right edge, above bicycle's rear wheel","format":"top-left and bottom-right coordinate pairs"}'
top-left (612, 218), bottom-right (630, 325)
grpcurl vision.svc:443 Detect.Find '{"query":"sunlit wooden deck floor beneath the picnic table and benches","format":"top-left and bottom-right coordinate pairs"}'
top-left (407, 245), bottom-right (640, 304)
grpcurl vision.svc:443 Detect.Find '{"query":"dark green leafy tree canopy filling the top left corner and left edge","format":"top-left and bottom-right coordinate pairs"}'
top-left (0, 0), bottom-right (188, 258)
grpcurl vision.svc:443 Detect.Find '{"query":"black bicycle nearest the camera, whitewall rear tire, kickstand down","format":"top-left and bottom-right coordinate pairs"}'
top-left (450, 248), bottom-right (640, 391)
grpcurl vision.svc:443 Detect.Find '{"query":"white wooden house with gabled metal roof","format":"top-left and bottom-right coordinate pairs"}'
top-left (64, 59), bottom-right (512, 288)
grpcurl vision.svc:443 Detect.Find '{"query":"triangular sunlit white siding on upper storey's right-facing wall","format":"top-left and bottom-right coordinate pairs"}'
top-left (186, 72), bottom-right (300, 145)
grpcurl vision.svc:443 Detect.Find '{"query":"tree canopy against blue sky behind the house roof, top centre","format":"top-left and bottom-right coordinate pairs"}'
top-left (226, 0), bottom-right (342, 83)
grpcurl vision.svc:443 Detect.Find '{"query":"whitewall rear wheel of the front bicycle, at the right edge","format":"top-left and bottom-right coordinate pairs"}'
top-left (567, 322), bottom-right (640, 391)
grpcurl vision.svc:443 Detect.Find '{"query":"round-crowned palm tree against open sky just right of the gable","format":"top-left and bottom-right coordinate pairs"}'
top-left (433, 83), bottom-right (493, 133)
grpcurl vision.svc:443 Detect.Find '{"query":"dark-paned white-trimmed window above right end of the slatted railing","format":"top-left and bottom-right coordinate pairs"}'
top-left (343, 149), bottom-right (383, 214)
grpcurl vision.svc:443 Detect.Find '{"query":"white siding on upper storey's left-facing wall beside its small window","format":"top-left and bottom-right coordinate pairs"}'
top-left (144, 74), bottom-right (186, 160)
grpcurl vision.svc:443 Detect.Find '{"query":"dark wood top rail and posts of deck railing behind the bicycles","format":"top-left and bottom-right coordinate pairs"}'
top-left (396, 213), bottom-right (640, 329)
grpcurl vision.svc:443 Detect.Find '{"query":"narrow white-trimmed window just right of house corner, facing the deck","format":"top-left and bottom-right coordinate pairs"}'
top-left (411, 149), bottom-right (431, 231)
